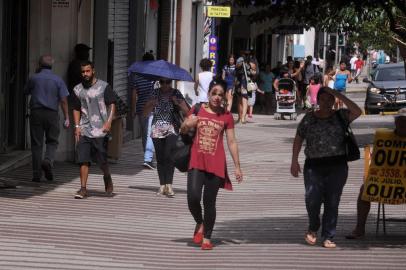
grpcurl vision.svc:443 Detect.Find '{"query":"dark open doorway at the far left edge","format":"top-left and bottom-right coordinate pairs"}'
top-left (0, 0), bottom-right (28, 153)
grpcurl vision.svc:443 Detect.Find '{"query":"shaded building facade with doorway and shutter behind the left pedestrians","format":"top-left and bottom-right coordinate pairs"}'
top-left (0, 0), bottom-right (157, 161)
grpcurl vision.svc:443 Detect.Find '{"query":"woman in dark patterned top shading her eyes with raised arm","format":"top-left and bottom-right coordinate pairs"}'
top-left (290, 87), bottom-right (362, 248)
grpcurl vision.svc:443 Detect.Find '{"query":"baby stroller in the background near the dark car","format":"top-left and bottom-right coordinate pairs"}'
top-left (274, 78), bottom-right (297, 120)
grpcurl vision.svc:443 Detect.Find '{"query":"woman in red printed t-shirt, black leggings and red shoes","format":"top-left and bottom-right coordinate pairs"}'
top-left (181, 79), bottom-right (242, 250)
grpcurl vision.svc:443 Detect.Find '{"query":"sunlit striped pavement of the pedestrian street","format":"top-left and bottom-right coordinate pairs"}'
top-left (0, 93), bottom-right (406, 270)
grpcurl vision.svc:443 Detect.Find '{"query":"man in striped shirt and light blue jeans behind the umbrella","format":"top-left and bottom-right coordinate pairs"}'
top-left (130, 53), bottom-right (155, 170)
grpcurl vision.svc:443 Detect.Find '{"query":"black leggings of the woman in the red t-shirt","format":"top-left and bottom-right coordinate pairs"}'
top-left (187, 169), bottom-right (223, 239)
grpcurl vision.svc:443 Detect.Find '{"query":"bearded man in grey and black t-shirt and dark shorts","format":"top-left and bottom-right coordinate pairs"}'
top-left (73, 61), bottom-right (116, 199)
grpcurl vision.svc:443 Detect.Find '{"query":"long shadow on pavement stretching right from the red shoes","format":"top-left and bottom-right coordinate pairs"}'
top-left (173, 215), bottom-right (406, 250)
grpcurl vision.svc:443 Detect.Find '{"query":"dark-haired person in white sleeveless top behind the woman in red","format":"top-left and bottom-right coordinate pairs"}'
top-left (195, 58), bottom-right (214, 103)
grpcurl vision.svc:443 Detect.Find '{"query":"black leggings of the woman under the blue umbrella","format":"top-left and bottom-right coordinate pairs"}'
top-left (152, 135), bottom-right (177, 185)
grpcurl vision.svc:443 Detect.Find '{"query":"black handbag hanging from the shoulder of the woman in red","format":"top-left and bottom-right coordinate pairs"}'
top-left (171, 103), bottom-right (201, 172)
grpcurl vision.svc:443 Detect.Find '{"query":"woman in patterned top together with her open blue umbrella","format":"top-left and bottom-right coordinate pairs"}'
top-left (128, 60), bottom-right (193, 197)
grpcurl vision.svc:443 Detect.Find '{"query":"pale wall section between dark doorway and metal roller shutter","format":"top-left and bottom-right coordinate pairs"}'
top-left (28, 0), bottom-right (93, 160)
